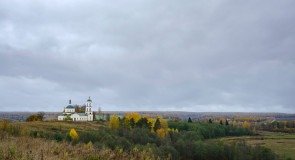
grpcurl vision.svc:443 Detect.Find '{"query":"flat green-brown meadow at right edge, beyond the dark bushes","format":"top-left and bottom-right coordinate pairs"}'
top-left (220, 131), bottom-right (295, 159)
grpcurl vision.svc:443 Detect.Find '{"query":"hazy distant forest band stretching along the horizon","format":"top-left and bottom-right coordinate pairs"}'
top-left (0, 112), bottom-right (295, 122)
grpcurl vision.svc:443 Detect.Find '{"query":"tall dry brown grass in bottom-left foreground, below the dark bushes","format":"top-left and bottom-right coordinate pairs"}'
top-left (0, 136), bottom-right (157, 160)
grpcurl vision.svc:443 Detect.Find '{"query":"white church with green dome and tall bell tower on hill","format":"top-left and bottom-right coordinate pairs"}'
top-left (58, 97), bottom-right (93, 121)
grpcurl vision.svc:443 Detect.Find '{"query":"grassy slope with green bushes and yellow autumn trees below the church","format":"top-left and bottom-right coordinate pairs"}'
top-left (0, 113), bottom-right (294, 160)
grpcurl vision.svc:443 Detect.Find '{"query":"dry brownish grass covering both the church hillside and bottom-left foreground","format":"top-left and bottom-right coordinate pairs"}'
top-left (0, 122), bottom-right (158, 160)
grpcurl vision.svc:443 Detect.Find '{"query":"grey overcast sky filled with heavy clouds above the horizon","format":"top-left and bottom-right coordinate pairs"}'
top-left (0, 0), bottom-right (295, 112)
